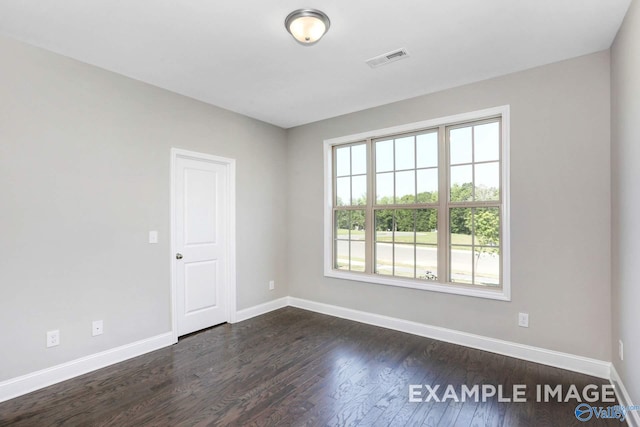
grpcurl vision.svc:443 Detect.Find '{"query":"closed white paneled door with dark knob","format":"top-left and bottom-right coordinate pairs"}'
top-left (173, 150), bottom-right (233, 336)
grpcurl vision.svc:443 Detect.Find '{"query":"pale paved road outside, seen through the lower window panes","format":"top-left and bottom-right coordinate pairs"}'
top-left (338, 240), bottom-right (500, 284)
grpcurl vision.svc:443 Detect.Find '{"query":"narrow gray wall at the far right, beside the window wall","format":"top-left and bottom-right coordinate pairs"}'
top-left (611, 1), bottom-right (640, 404)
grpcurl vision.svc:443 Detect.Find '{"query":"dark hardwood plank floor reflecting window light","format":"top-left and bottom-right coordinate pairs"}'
top-left (0, 308), bottom-right (623, 427)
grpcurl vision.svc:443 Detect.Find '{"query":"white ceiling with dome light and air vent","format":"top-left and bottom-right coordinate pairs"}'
top-left (0, 0), bottom-right (631, 128)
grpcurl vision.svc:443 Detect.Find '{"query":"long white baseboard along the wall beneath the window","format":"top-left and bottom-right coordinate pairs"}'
top-left (289, 297), bottom-right (611, 379)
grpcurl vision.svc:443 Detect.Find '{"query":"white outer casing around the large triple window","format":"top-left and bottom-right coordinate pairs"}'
top-left (324, 105), bottom-right (511, 301)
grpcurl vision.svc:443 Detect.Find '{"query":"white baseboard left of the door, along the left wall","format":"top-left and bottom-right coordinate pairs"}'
top-left (0, 332), bottom-right (174, 402)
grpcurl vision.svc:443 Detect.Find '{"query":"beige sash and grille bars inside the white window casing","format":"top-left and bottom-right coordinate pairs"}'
top-left (331, 112), bottom-right (508, 296)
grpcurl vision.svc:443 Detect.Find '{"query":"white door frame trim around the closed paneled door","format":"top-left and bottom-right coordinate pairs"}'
top-left (169, 148), bottom-right (236, 343)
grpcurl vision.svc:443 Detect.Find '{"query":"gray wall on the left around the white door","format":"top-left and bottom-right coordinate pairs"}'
top-left (0, 39), bottom-right (288, 381)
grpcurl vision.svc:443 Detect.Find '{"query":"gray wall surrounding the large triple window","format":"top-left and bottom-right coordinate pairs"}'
top-left (288, 51), bottom-right (611, 360)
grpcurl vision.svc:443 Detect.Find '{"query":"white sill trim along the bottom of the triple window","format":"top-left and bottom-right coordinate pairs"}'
top-left (324, 269), bottom-right (511, 301)
